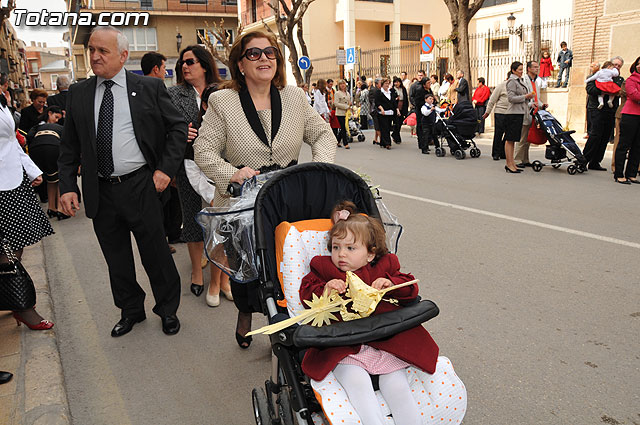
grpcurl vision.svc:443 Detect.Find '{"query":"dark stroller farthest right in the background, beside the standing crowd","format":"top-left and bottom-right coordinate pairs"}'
top-left (531, 110), bottom-right (587, 175)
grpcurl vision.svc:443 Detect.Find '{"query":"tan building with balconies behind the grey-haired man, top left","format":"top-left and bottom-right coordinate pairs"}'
top-left (66, 0), bottom-right (238, 85)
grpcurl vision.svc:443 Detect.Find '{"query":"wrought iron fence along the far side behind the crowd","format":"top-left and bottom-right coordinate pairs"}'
top-left (311, 20), bottom-right (573, 86)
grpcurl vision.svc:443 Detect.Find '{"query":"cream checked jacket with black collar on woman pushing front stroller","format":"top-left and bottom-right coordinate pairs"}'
top-left (193, 86), bottom-right (336, 206)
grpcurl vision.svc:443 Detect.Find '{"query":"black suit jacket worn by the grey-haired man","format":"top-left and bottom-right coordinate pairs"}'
top-left (58, 72), bottom-right (187, 218)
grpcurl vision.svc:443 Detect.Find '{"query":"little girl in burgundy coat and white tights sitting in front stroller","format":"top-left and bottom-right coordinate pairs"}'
top-left (300, 202), bottom-right (438, 425)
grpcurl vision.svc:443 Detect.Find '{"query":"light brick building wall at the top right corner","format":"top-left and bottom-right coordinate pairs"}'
top-left (568, 0), bottom-right (640, 130)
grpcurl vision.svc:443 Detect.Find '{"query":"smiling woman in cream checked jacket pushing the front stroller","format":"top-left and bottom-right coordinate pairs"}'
top-left (193, 31), bottom-right (336, 348)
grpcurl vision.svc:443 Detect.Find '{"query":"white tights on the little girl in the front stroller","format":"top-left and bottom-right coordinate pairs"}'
top-left (333, 364), bottom-right (422, 425)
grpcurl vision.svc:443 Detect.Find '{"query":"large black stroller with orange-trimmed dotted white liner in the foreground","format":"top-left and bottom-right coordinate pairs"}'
top-left (202, 163), bottom-right (466, 425)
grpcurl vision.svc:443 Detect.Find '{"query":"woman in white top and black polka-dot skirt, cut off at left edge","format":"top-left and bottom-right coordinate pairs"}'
top-left (0, 93), bottom-right (53, 330)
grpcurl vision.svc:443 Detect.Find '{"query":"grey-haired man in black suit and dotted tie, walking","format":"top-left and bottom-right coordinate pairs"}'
top-left (58, 27), bottom-right (187, 337)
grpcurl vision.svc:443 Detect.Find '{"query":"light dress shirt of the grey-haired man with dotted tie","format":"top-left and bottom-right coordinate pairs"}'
top-left (93, 67), bottom-right (147, 177)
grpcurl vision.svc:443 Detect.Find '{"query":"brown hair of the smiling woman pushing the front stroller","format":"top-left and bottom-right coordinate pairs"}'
top-left (225, 30), bottom-right (287, 91)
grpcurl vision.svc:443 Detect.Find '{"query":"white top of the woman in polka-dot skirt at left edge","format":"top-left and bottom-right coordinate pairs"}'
top-left (0, 105), bottom-right (42, 190)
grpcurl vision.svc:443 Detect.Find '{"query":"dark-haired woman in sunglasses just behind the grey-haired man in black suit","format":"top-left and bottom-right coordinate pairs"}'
top-left (169, 45), bottom-right (232, 307)
